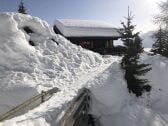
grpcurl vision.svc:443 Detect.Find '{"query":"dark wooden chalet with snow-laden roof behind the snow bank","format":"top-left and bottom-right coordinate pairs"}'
top-left (53, 19), bottom-right (121, 54)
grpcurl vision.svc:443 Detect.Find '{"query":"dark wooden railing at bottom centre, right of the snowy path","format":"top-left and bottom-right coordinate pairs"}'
top-left (58, 88), bottom-right (91, 126)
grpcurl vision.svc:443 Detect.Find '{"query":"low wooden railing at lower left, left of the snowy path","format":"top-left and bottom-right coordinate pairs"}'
top-left (0, 87), bottom-right (59, 121)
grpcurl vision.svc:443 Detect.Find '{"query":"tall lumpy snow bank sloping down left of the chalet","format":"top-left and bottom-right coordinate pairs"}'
top-left (0, 13), bottom-right (108, 120)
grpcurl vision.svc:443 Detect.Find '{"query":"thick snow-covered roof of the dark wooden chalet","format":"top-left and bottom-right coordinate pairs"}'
top-left (54, 19), bottom-right (121, 37)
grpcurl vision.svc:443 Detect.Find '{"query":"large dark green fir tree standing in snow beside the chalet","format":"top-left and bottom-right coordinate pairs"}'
top-left (121, 6), bottom-right (151, 97)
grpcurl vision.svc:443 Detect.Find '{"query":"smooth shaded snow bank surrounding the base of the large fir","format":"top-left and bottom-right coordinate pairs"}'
top-left (88, 53), bottom-right (168, 126)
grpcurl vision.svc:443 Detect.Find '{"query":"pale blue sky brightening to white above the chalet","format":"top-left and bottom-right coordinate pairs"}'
top-left (0, 0), bottom-right (160, 32)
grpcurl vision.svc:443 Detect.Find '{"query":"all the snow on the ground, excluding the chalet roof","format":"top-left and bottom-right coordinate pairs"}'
top-left (0, 13), bottom-right (168, 126)
